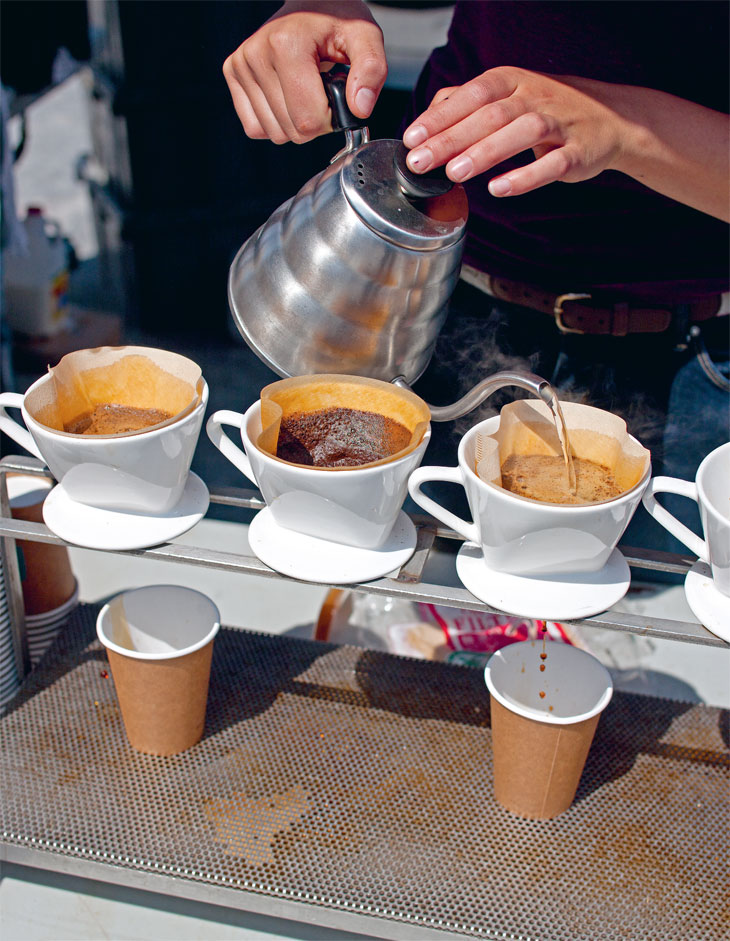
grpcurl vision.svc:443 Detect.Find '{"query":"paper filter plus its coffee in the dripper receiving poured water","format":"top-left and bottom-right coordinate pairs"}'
top-left (474, 400), bottom-right (650, 505)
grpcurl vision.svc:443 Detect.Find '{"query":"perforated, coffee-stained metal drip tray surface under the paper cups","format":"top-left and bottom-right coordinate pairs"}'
top-left (0, 606), bottom-right (730, 941)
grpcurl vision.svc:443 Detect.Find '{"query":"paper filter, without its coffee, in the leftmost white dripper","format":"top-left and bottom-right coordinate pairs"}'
top-left (26, 346), bottom-right (203, 437)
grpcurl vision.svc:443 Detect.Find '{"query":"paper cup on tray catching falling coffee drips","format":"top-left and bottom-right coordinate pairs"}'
top-left (484, 640), bottom-right (613, 820)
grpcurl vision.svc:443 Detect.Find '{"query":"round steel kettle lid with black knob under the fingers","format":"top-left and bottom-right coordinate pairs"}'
top-left (338, 139), bottom-right (469, 251)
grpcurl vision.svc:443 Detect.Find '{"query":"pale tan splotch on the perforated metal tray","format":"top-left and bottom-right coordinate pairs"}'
top-left (205, 784), bottom-right (312, 866)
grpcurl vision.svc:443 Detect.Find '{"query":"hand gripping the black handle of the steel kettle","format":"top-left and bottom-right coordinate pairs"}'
top-left (223, 0), bottom-right (388, 144)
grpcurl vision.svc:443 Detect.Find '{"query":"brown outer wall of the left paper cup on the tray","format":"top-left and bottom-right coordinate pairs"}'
top-left (107, 641), bottom-right (213, 755)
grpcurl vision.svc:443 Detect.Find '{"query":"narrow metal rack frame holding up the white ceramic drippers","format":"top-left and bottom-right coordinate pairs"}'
top-left (0, 456), bottom-right (728, 677)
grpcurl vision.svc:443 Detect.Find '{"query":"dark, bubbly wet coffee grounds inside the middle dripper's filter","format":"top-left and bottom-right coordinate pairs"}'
top-left (276, 407), bottom-right (411, 467)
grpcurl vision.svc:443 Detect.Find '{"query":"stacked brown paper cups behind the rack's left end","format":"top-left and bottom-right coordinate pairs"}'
top-left (7, 474), bottom-right (78, 666)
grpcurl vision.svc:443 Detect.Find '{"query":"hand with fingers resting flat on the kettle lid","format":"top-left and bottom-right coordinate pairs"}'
top-left (403, 66), bottom-right (632, 196)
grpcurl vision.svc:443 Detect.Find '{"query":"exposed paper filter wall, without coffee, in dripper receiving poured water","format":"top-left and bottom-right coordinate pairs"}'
top-left (472, 399), bottom-right (651, 493)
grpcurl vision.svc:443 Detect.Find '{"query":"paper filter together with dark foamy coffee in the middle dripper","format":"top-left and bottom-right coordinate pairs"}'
top-left (256, 374), bottom-right (431, 470)
